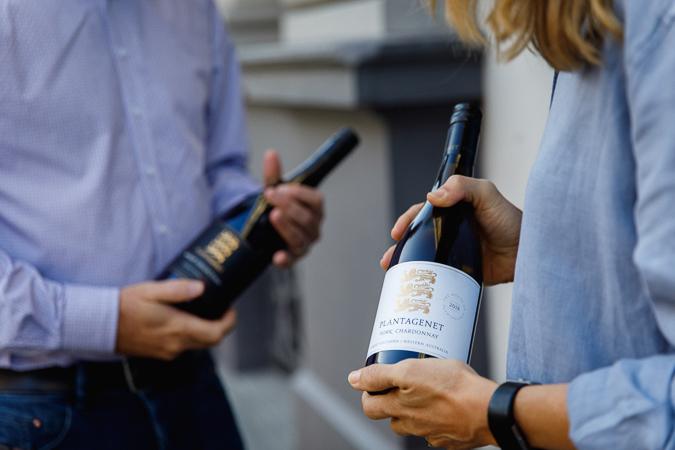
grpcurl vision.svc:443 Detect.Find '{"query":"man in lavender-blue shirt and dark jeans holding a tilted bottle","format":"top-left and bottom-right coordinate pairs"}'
top-left (0, 0), bottom-right (322, 450)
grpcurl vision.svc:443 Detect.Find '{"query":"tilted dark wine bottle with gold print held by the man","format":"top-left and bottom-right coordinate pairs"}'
top-left (158, 128), bottom-right (359, 319)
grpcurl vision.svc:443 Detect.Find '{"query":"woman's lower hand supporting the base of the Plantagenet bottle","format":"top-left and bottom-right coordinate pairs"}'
top-left (349, 359), bottom-right (497, 449)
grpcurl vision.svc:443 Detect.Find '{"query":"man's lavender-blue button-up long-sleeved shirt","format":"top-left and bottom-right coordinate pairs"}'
top-left (0, 0), bottom-right (256, 369)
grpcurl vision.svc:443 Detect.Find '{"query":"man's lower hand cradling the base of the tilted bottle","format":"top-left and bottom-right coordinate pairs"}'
top-left (116, 280), bottom-right (236, 360)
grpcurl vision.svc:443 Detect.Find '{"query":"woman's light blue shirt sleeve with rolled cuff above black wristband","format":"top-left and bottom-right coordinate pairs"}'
top-left (568, 7), bottom-right (675, 449)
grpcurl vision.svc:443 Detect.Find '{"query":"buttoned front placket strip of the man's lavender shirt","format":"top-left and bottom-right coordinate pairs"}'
top-left (107, 0), bottom-right (172, 268)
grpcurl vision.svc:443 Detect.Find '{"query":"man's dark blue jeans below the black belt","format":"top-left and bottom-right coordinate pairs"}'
top-left (0, 359), bottom-right (243, 450)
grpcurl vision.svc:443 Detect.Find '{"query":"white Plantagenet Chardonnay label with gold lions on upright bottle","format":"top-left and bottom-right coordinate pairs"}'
top-left (368, 261), bottom-right (480, 362)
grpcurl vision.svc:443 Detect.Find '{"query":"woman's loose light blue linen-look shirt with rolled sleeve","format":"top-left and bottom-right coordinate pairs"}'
top-left (508, 0), bottom-right (675, 449)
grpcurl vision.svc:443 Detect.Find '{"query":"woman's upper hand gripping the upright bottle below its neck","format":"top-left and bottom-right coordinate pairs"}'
top-left (380, 175), bottom-right (522, 285)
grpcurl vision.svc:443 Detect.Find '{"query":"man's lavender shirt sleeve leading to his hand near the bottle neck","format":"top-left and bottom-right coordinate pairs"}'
top-left (206, 7), bottom-right (260, 214)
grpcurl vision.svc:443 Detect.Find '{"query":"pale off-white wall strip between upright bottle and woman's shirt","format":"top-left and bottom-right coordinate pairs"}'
top-left (481, 52), bottom-right (553, 380)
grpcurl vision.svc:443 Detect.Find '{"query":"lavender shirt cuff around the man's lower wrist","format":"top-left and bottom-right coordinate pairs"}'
top-left (62, 285), bottom-right (119, 354)
